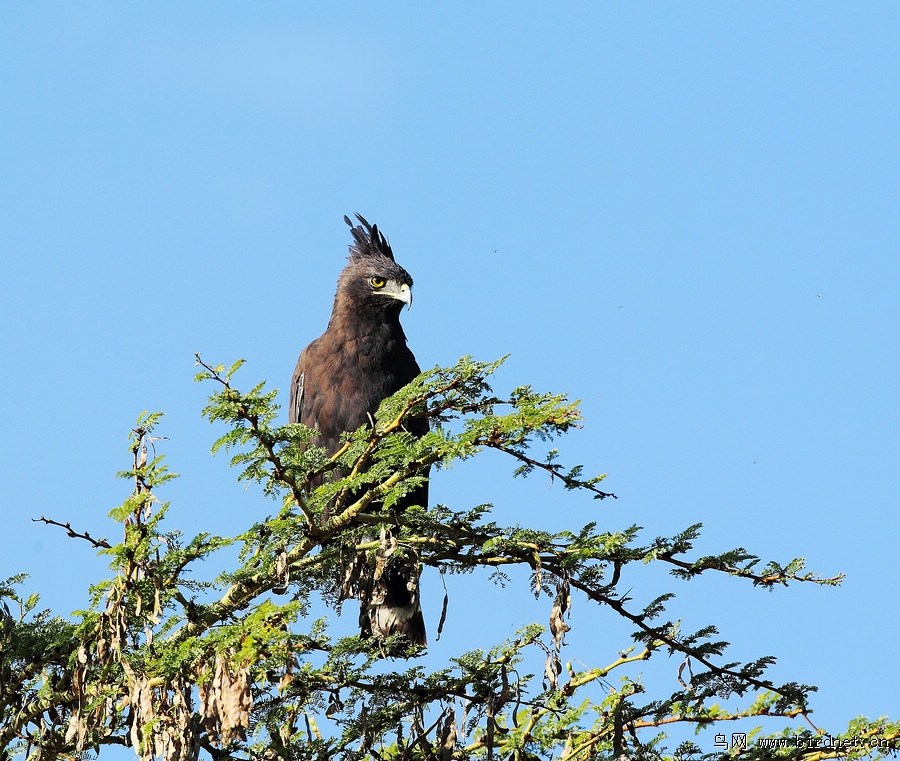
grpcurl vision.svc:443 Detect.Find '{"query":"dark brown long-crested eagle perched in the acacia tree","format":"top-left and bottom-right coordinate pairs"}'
top-left (288, 214), bottom-right (428, 647)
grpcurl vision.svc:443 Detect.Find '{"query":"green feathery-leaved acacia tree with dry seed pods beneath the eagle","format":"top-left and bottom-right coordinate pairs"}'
top-left (0, 357), bottom-right (900, 761)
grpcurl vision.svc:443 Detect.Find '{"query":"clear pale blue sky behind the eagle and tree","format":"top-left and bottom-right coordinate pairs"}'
top-left (0, 2), bottom-right (900, 756)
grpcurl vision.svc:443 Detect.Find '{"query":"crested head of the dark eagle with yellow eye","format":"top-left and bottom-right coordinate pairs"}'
top-left (338, 214), bottom-right (412, 316)
